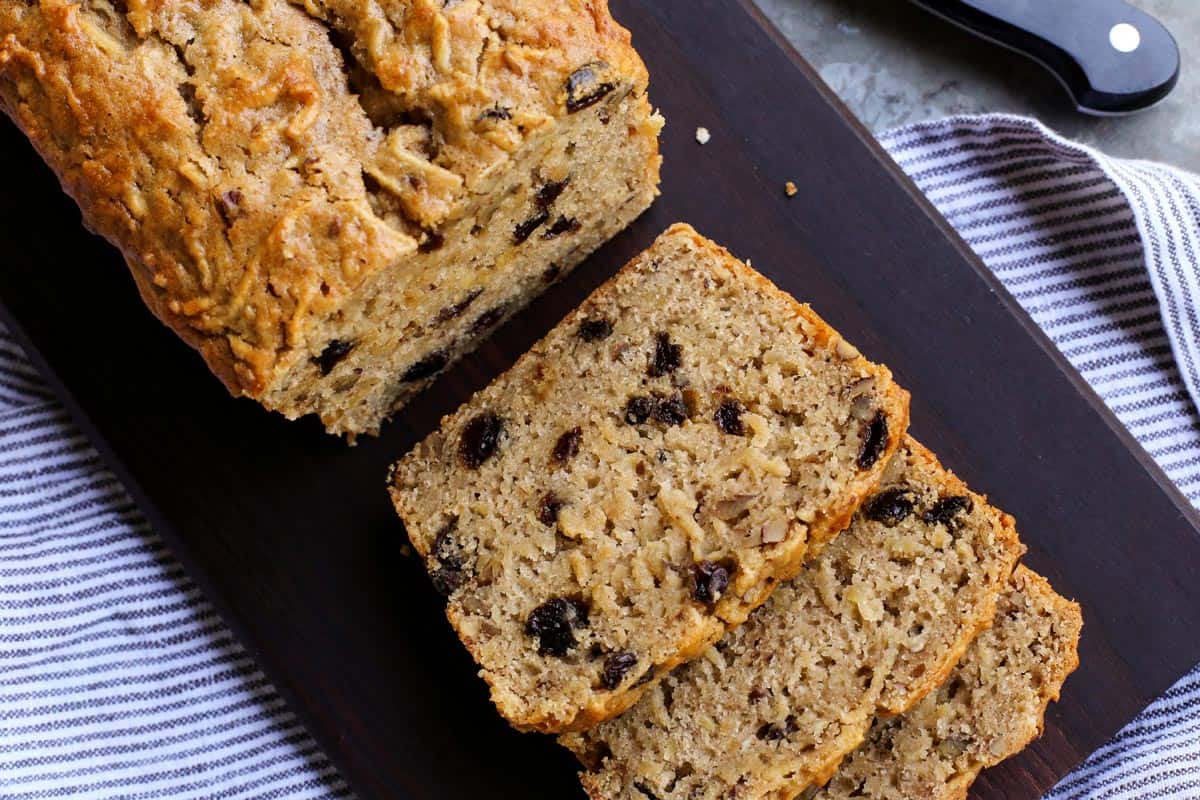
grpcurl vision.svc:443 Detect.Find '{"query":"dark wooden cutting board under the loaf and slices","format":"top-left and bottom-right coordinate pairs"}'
top-left (0, 0), bottom-right (1200, 800)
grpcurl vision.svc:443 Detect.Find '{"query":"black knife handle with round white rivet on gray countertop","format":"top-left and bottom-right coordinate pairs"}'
top-left (913, 0), bottom-right (1180, 114)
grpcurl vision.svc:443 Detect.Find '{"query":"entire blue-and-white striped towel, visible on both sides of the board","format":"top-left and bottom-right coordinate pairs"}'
top-left (0, 116), bottom-right (1200, 800)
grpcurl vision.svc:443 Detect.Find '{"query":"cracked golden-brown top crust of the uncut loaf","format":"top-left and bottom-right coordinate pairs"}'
top-left (0, 0), bottom-right (647, 396)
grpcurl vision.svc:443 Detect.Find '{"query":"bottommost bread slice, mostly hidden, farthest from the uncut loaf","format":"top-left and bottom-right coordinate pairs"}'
top-left (810, 567), bottom-right (1082, 800)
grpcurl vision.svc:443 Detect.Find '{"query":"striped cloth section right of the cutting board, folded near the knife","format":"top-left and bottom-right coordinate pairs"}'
top-left (882, 115), bottom-right (1200, 800)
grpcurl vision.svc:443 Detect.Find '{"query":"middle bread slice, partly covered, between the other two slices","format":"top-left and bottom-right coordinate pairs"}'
top-left (562, 439), bottom-right (1022, 800)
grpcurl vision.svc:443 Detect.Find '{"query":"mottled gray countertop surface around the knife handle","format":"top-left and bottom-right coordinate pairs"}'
top-left (756, 0), bottom-right (1200, 173)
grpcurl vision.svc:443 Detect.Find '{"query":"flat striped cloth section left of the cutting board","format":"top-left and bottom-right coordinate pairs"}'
top-left (0, 371), bottom-right (349, 800)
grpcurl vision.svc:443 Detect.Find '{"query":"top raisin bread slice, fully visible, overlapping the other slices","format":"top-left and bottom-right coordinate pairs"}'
top-left (391, 225), bottom-right (908, 730)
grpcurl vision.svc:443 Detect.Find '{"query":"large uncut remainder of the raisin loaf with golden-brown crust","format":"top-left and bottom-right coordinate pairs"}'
top-left (0, 0), bottom-right (661, 434)
